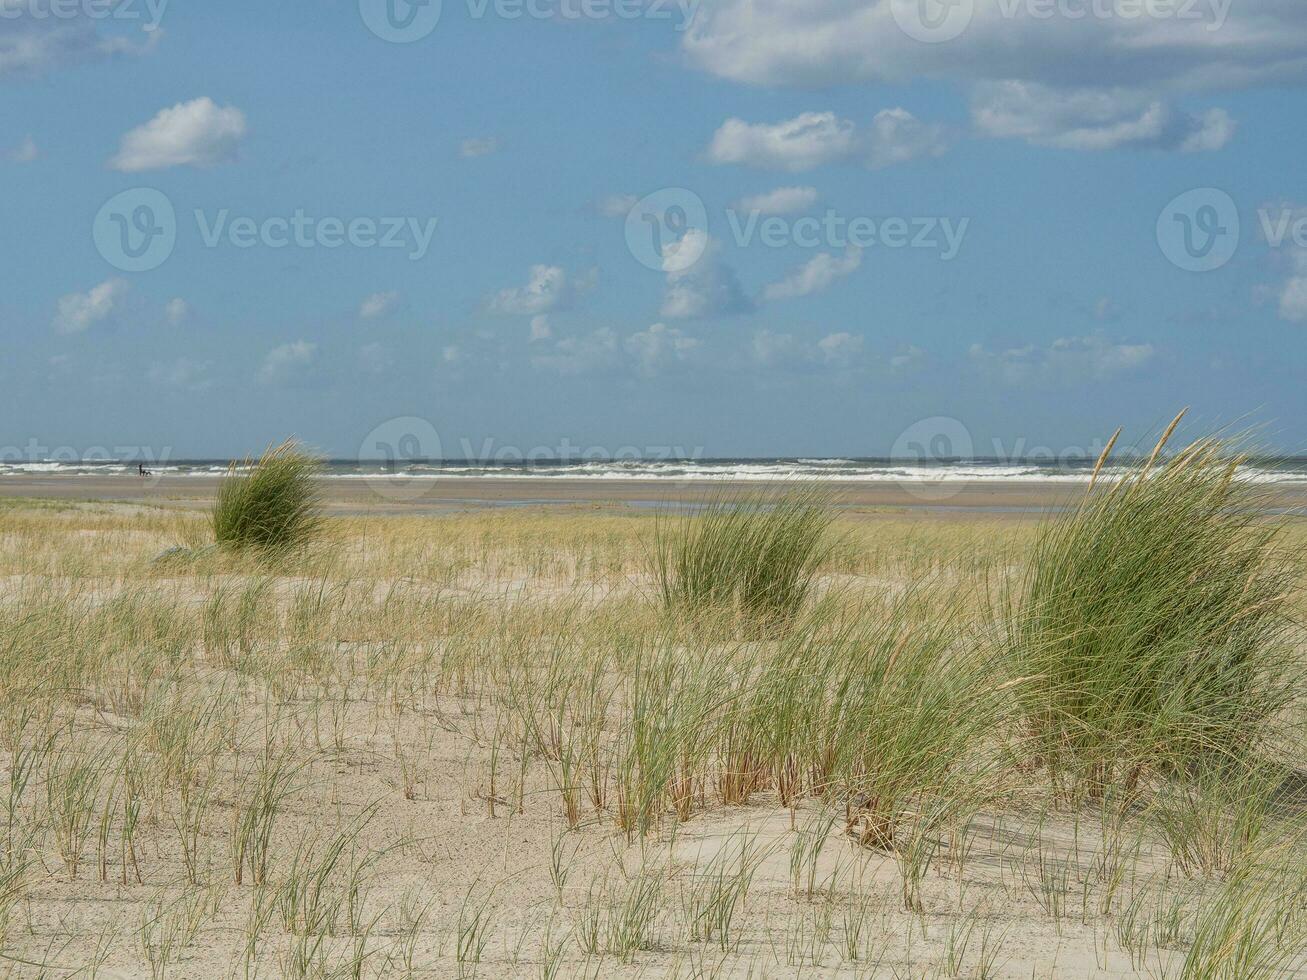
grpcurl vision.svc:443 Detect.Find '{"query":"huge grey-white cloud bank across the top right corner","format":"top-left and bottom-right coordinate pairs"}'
top-left (682, 0), bottom-right (1270, 152)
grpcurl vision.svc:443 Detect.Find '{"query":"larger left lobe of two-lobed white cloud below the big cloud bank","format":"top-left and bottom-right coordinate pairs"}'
top-left (708, 112), bottom-right (856, 172)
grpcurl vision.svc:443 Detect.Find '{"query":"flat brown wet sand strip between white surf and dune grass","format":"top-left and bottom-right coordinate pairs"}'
top-left (0, 474), bottom-right (1307, 517)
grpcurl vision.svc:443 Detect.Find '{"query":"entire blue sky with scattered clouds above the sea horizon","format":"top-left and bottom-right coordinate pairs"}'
top-left (0, 0), bottom-right (1307, 460)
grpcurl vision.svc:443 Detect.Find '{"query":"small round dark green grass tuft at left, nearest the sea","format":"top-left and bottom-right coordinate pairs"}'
top-left (210, 439), bottom-right (322, 553)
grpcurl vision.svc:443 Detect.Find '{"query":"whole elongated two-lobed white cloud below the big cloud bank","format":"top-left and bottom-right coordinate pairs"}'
top-left (707, 108), bottom-right (950, 172)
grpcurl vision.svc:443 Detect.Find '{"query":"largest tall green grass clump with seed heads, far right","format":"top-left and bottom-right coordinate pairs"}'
top-left (1006, 413), bottom-right (1300, 794)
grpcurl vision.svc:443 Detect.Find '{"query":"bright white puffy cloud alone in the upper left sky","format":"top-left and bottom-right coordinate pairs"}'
top-left (108, 95), bottom-right (246, 172)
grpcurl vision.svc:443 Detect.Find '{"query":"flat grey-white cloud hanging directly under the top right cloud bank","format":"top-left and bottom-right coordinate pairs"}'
top-left (971, 81), bottom-right (1235, 153)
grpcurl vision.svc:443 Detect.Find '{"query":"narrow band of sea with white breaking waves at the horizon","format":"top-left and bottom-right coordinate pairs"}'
top-left (0, 456), bottom-right (1307, 483)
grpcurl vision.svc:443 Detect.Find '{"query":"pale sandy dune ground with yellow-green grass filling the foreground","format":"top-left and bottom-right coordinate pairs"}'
top-left (0, 465), bottom-right (1307, 979)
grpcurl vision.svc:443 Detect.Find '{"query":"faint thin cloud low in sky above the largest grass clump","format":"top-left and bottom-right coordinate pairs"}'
top-left (970, 333), bottom-right (1157, 385)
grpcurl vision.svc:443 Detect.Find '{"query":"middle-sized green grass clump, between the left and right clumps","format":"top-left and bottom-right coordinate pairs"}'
top-left (654, 490), bottom-right (831, 621)
